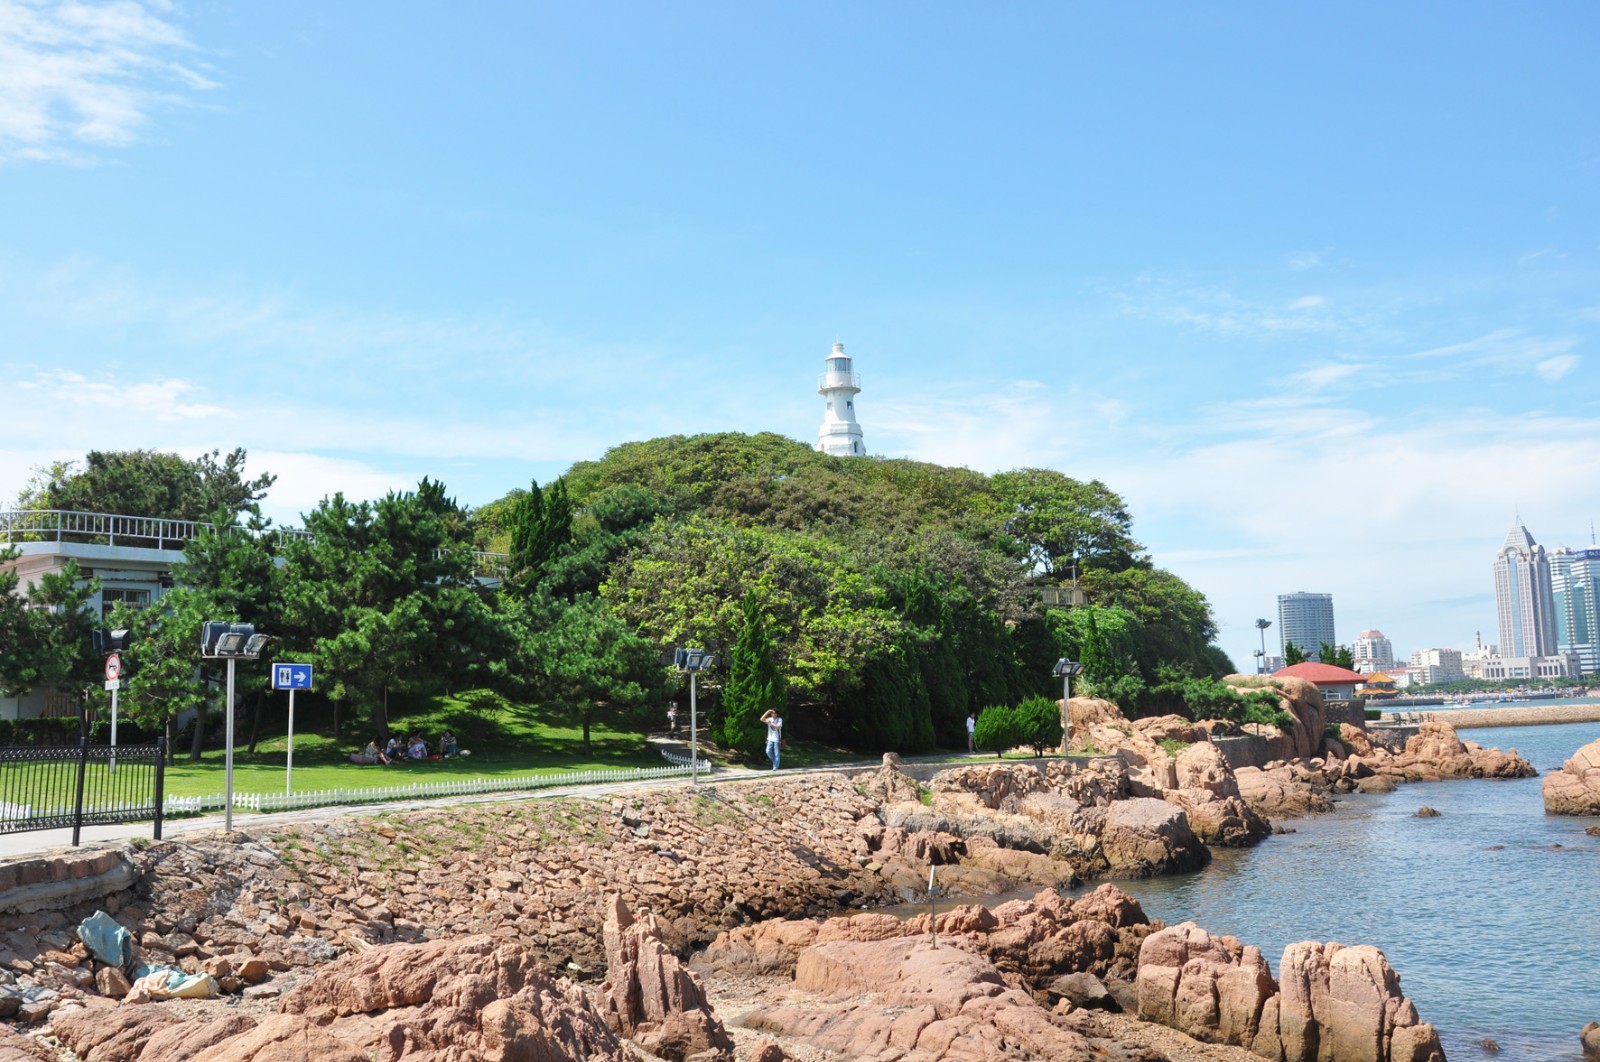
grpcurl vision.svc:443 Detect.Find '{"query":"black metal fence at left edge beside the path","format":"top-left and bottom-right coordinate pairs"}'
top-left (0, 736), bottom-right (166, 844)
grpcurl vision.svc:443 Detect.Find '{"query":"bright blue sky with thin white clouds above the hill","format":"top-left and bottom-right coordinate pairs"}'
top-left (0, 0), bottom-right (1600, 669)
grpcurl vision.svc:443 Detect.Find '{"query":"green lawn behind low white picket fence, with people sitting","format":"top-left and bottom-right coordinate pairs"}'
top-left (154, 693), bottom-right (666, 797)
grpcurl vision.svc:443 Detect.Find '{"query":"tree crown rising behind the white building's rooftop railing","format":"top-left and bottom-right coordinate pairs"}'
top-left (21, 449), bottom-right (277, 520)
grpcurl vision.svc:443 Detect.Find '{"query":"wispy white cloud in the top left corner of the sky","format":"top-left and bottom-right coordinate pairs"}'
top-left (0, 0), bottom-right (216, 163)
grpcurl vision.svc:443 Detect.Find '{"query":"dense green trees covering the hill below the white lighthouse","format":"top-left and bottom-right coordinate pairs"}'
top-left (0, 433), bottom-right (1230, 752)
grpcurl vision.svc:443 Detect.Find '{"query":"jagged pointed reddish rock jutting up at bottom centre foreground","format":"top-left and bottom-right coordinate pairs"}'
top-left (598, 896), bottom-right (733, 1062)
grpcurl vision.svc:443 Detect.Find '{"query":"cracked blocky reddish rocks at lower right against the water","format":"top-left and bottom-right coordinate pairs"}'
top-left (1136, 923), bottom-right (1445, 1062)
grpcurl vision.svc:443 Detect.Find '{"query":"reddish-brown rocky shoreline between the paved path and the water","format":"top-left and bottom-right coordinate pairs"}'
top-left (0, 674), bottom-right (1531, 1062)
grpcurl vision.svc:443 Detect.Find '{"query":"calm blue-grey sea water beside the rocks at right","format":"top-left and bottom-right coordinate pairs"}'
top-left (1094, 712), bottom-right (1600, 1062)
